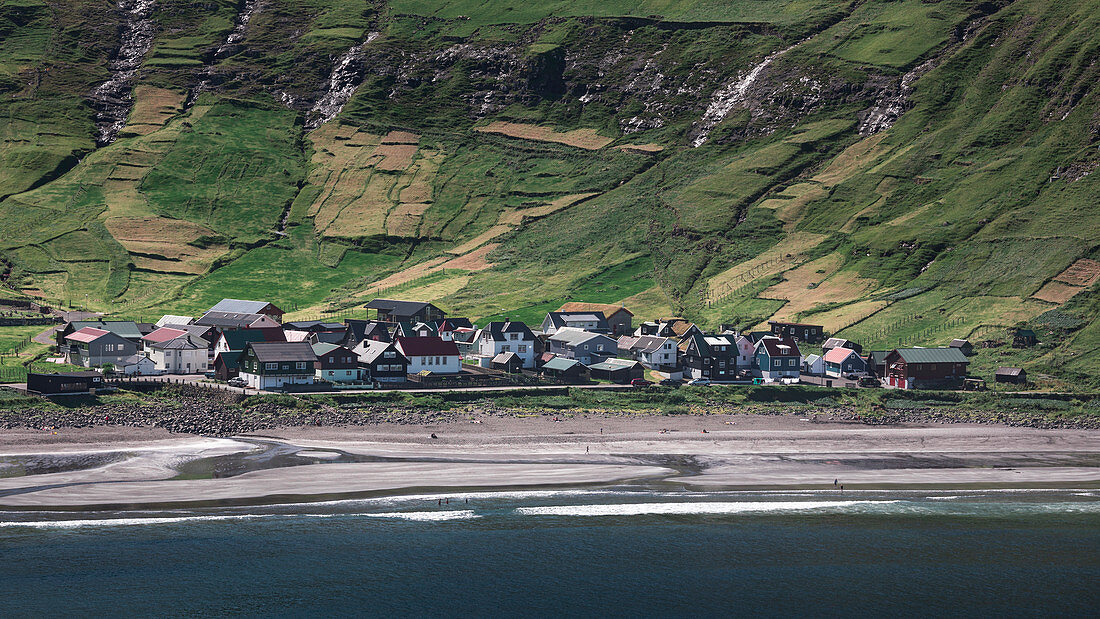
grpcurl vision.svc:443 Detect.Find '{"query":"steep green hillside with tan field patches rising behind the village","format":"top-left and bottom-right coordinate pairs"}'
top-left (0, 0), bottom-right (1100, 386)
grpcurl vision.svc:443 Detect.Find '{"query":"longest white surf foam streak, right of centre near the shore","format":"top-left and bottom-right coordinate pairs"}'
top-left (516, 500), bottom-right (899, 516)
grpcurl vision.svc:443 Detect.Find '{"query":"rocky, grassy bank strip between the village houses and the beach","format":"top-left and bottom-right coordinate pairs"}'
top-left (0, 385), bottom-right (1100, 434)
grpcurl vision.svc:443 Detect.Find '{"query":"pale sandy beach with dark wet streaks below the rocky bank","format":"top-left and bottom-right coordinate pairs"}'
top-left (0, 414), bottom-right (1100, 509)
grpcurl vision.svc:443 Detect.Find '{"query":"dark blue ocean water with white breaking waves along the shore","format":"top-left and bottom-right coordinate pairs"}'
top-left (0, 486), bottom-right (1100, 617)
